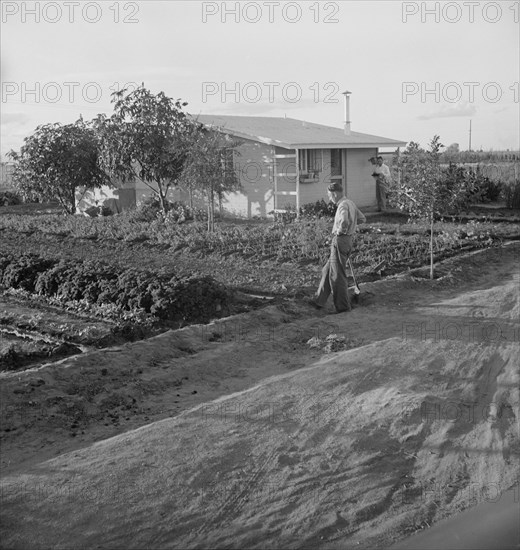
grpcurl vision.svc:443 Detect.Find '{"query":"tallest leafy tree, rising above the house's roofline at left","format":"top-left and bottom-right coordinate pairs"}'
top-left (95, 85), bottom-right (193, 213)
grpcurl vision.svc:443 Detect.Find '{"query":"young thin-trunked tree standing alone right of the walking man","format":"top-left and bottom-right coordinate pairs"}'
top-left (390, 136), bottom-right (468, 279)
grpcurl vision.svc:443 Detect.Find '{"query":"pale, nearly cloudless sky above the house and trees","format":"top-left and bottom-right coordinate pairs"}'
top-left (0, 0), bottom-right (520, 160)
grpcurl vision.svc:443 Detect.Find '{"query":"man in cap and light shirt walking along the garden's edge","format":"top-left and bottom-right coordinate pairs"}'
top-left (314, 182), bottom-right (366, 313)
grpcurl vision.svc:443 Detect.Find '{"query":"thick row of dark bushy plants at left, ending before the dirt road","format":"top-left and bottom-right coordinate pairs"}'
top-left (0, 254), bottom-right (231, 323)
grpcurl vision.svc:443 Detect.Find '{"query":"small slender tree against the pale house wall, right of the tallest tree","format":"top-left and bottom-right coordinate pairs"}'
top-left (181, 124), bottom-right (240, 232)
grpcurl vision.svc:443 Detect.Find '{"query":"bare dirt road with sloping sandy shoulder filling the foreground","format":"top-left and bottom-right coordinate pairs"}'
top-left (1, 244), bottom-right (520, 548)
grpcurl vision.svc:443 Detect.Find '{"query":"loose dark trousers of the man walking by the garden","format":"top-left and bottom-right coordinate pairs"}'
top-left (315, 235), bottom-right (353, 313)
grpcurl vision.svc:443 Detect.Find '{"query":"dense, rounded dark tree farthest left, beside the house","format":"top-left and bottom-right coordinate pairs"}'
top-left (8, 118), bottom-right (110, 214)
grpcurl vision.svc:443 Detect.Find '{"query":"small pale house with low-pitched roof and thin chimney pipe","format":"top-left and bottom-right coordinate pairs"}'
top-left (78, 96), bottom-right (406, 218)
